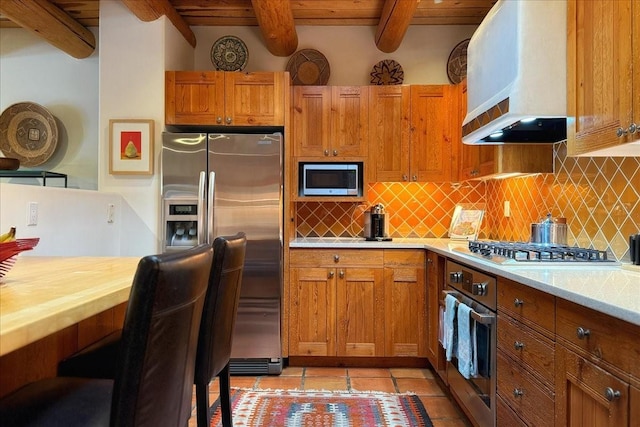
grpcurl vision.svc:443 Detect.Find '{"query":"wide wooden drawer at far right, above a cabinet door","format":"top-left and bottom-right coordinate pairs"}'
top-left (556, 298), bottom-right (640, 376)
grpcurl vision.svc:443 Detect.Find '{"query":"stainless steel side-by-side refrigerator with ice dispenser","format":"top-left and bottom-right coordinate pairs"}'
top-left (161, 132), bottom-right (283, 374)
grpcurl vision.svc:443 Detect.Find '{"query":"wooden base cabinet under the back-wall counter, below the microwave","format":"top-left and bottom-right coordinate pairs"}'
top-left (289, 249), bottom-right (426, 357)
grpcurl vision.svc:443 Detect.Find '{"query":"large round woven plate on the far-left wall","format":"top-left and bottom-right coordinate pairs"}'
top-left (0, 102), bottom-right (58, 166)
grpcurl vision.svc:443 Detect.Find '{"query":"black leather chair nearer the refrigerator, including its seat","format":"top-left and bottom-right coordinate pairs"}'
top-left (58, 233), bottom-right (246, 427)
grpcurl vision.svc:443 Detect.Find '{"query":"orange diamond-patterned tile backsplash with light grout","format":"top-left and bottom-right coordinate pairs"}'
top-left (296, 143), bottom-right (640, 261)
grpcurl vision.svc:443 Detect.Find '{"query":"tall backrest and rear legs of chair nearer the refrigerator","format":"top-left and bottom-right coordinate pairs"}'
top-left (194, 233), bottom-right (246, 427)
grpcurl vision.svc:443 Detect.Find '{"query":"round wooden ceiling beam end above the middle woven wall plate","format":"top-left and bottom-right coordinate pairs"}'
top-left (251, 0), bottom-right (298, 56)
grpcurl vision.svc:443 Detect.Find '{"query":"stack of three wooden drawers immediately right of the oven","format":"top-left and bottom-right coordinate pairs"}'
top-left (497, 277), bottom-right (555, 426)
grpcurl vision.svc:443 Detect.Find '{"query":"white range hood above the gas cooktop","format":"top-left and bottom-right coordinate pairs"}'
top-left (462, 0), bottom-right (567, 144)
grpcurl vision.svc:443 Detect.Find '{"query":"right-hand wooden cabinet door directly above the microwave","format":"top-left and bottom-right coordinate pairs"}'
top-left (329, 86), bottom-right (369, 157)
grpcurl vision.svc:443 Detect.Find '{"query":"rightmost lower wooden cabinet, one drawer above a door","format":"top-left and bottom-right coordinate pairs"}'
top-left (555, 299), bottom-right (640, 426)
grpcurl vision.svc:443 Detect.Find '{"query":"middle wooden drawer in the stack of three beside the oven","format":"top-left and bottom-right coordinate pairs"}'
top-left (498, 314), bottom-right (555, 387)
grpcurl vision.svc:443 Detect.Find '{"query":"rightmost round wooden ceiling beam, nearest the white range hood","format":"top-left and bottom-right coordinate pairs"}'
top-left (376, 0), bottom-right (420, 53)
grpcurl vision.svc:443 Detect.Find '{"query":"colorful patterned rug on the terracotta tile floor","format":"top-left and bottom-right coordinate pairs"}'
top-left (211, 389), bottom-right (433, 427)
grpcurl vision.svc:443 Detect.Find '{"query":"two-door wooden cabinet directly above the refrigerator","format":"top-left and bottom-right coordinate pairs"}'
top-left (165, 71), bottom-right (289, 126)
